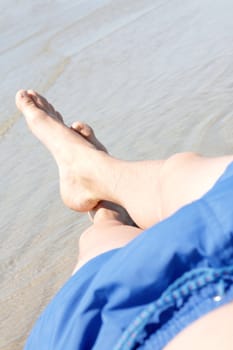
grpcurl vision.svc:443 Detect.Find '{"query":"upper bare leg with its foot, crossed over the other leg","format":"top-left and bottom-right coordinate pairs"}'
top-left (16, 91), bottom-right (233, 228)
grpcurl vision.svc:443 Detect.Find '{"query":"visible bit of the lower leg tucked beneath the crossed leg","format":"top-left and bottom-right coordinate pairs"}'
top-left (73, 202), bottom-right (142, 274)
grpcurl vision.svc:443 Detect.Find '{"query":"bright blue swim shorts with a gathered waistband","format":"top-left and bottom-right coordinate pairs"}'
top-left (25, 163), bottom-right (233, 350)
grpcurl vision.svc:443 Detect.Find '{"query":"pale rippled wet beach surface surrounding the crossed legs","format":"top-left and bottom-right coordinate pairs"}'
top-left (0, 0), bottom-right (233, 350)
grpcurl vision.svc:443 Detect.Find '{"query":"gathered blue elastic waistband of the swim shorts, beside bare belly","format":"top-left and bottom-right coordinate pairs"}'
top-left (114, 265), bottom-right (233, 350)
